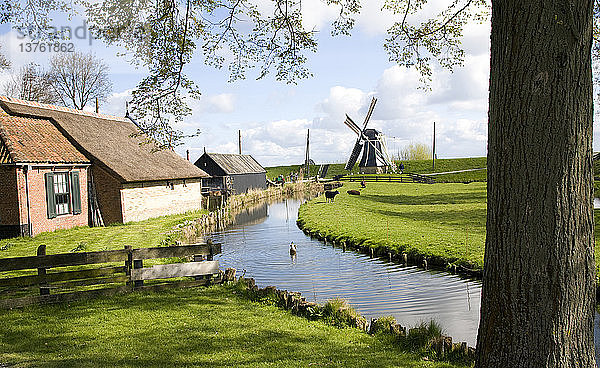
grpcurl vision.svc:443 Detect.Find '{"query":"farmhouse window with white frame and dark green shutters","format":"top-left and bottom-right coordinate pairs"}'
top-left (46, 171), bottom-right (81, 218)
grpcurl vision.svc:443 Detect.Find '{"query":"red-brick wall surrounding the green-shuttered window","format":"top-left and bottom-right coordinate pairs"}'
top-left (17, 167), bottom-right (88, 236)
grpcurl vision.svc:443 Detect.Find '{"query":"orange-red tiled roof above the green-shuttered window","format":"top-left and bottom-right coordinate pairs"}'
top-left (0, 109), bottom-right (90, 163)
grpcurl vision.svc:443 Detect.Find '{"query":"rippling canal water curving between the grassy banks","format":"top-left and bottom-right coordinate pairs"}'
top-left (211, 199), bottom-right (600, 360)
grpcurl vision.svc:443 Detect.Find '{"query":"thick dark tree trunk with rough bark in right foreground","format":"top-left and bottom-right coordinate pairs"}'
top-left (476, 0), bottom-right (595, 368)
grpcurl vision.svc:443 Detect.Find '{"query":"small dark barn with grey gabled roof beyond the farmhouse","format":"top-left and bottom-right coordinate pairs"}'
top-left (194, 152), bottom-right (267, 194)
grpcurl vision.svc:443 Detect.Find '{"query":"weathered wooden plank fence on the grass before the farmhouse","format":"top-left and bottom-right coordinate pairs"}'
top-left (0, 244), bottom-right (221, 309)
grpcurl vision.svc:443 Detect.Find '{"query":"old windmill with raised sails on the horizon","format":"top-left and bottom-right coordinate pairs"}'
top-left (344, 97), bottom-right (395, 174)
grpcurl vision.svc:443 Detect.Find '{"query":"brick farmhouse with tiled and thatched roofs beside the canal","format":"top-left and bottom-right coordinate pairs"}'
top-left (0, 96), bottom-right (208, 238)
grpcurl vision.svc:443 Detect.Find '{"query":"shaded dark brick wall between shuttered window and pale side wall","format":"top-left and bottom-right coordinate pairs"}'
top-left (92, 165), bottom-right (123, 225)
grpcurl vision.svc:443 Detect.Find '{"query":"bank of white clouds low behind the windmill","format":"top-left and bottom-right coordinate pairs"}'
top-left (205, 56), bottom-right (488, 166)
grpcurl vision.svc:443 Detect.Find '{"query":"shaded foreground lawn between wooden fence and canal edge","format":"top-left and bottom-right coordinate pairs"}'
top-left (0, 286), bottom-right (464, 368)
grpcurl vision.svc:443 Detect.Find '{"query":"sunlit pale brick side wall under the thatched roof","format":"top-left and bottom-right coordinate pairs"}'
top-left (121, 179), bottom-right (202, 222)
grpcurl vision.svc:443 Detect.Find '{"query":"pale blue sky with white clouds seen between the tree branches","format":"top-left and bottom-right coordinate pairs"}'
top-left (0, 0), bottom-right (600, 166)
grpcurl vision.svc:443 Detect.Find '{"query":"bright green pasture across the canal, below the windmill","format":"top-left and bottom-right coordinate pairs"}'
top-left (299, 183), bottom-right (600, 274)
